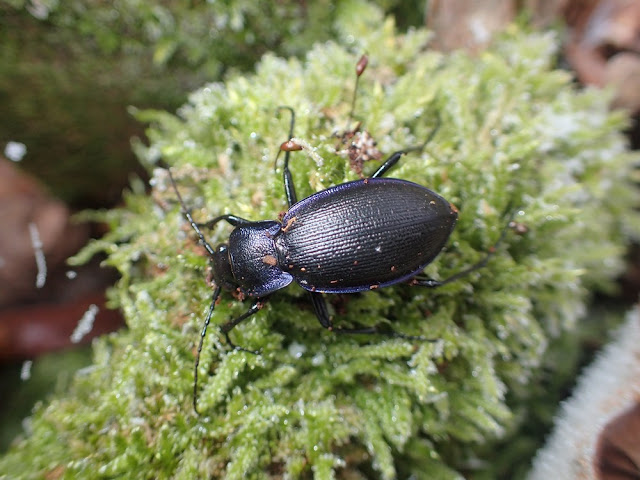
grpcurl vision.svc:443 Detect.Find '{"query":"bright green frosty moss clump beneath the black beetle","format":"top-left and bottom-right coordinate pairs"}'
top-left (0, 20), bottom-right (638, 479)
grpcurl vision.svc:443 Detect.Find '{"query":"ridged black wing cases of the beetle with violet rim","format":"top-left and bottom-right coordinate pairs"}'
top-left (275, 178), bottom-right (457, 293)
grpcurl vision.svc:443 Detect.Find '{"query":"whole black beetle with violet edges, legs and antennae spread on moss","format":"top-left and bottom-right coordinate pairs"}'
top-left (165, 107), bottom-right (506, 413)
